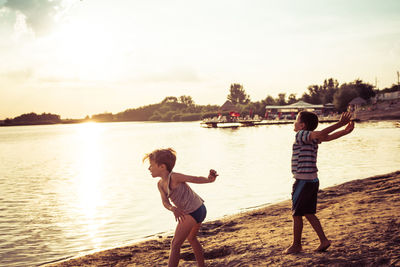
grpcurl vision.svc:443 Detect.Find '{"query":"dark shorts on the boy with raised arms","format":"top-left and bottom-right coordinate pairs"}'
top-left (292, 178), bottom-right (319, 216)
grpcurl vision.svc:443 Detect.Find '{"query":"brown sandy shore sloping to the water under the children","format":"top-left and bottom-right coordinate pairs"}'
top-left (49, 171), bottom-right (400, 267)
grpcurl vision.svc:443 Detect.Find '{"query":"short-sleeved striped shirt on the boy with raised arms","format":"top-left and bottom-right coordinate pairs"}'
top-left (292, 130), bottom-right (319, 180)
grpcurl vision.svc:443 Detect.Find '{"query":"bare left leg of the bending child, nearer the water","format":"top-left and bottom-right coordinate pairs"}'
top-left (168, 215), bottom-right (197, 267)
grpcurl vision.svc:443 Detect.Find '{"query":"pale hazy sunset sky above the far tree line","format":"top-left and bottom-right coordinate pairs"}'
top-left (0, 0), bottom-right (400, 120)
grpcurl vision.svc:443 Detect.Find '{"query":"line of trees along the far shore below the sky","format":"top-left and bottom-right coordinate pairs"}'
top-left (2, 78), bottom-right (400, 125)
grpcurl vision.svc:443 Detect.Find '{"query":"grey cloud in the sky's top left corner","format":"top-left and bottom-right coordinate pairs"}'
top-left (0, 0), bottom-right (66, 36)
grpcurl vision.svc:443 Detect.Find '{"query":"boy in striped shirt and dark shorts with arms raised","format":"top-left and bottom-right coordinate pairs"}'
top-left (286, 111), bottom-right (354, 254)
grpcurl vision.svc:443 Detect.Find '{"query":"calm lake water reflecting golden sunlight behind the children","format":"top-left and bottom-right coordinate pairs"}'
top-left (0, 121), bottom-right (400, 266)
